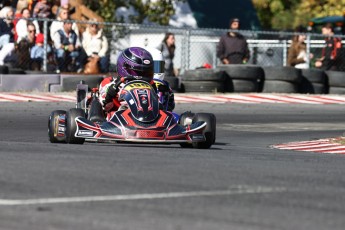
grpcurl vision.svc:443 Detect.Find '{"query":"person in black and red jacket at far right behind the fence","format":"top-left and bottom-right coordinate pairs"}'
top-left (315, 23), bottom-right (342, 70)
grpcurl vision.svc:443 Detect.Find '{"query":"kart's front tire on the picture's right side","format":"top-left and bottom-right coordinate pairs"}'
top-left (193, 113), bottom-right (216, 149)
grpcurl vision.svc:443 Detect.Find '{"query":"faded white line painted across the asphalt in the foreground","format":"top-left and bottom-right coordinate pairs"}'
top-left (0, 186), bottom-right (287, 206)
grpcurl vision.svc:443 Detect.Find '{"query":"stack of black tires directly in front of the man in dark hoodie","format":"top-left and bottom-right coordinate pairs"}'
top-left (217, 64), bottom-right (264, 93)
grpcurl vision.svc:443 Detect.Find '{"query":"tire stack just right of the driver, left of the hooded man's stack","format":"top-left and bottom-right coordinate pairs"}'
top-left (180, 69), bottom-right (228, 93)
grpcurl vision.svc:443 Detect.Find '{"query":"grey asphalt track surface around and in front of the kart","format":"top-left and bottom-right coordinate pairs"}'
top-left (0, 102), bottom-right (345, 230)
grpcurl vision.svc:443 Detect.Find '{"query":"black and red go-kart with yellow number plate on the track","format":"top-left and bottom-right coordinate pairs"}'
top-left (48, 76), bottom-right (216, 149)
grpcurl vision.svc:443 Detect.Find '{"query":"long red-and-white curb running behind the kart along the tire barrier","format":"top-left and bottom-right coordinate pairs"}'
top-left (0, 92), bottom-right (345, 104)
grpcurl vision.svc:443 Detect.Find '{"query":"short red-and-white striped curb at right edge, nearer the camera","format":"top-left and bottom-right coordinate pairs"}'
top-left (270, 137), bottom-right (345, 154)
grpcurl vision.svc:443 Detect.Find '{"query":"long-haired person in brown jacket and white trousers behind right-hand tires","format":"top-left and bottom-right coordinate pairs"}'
top-left (288, 26), bottom-right (314, 69)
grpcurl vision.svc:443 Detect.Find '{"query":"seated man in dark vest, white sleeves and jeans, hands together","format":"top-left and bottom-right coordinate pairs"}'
top-left (52, 20), bottom-right (83, 72)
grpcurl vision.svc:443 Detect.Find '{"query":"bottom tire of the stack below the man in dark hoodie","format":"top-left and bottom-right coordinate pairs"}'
top-left (226, 79), bottom-right (259, 93)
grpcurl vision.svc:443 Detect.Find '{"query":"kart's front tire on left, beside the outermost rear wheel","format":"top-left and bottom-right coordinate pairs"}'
top-left (65, 108), bottom-right (85, 144)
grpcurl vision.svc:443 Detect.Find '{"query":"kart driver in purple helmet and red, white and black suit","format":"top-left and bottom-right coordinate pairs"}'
top-left (99, 47), bottom-right (175, 117)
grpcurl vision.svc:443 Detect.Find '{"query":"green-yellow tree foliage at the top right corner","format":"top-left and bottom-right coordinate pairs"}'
top-left (252, 0), bottom-right (345, 29)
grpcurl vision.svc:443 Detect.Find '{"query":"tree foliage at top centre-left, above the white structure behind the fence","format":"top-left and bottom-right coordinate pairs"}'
top-left (85, 0), bottom-right (177, 25)
